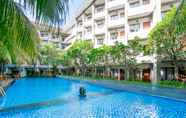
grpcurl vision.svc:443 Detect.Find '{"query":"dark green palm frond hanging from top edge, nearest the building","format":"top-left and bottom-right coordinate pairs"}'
top-left (23, 0), bottom-right (69, 26)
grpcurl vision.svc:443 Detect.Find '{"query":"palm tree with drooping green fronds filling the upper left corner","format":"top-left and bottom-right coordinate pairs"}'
top-left (0, 0), bottom-right (68, 74)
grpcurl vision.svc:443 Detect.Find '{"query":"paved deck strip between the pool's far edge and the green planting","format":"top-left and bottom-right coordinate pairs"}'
top-left (64, 77), bottom-right (186, 102)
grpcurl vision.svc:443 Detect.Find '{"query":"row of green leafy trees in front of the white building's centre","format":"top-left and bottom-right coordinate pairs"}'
top-left (62, 38), bottom-right (142, 67)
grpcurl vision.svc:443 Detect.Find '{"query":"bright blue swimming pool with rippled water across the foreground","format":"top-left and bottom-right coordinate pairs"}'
top-left (0, 78), bottom-right (186, 118)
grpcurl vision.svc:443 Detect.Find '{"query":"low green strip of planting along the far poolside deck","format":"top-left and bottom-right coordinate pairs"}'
top-left (62, 76), bottom-right (186, 89)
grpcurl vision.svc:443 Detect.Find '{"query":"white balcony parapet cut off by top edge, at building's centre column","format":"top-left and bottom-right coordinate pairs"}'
top-left (108, 0), bottom-right (125, 9)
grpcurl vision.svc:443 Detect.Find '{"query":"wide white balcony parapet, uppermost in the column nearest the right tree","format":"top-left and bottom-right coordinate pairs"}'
top-left (128, 2), bottom-right (154, 18)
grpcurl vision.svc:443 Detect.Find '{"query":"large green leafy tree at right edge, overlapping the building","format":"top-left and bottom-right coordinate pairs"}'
top-left (148, 0), bottom-right (186, 60)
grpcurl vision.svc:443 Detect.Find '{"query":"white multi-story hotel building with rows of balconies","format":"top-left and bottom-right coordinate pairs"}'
top-left (63, 0), bottom-right (180, 80)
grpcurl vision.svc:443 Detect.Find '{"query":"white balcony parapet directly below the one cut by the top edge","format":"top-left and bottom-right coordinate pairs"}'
top-left (108, 17), bottom-right (125, 28)
